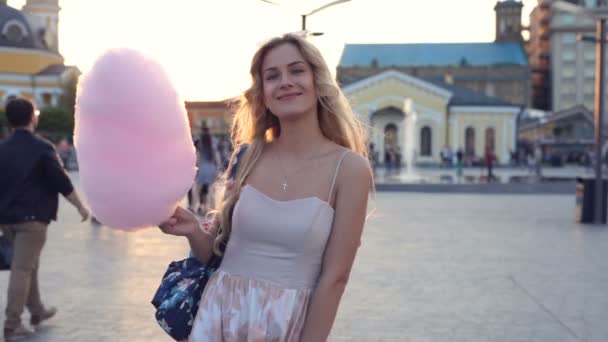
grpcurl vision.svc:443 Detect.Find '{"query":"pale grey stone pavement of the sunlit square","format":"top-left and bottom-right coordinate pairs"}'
top-left (0, 175), bottom-right (608, 342)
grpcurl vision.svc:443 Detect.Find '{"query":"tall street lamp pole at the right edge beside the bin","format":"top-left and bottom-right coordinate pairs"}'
top-left (553, 0), bottom-right (608, 224)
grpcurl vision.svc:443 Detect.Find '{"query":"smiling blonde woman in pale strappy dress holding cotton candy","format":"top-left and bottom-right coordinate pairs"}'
top-left (161, 34), bottom-right (372, 342)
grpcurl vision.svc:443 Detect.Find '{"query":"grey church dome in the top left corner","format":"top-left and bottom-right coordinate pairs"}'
top-left (0, 2), bottom-right (46, 50)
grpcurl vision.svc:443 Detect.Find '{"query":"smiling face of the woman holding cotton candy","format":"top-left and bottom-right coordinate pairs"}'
top-left (262, 43), bottom-right (317, 119)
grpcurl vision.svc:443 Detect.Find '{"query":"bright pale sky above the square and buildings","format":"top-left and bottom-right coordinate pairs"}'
top-left (8, 0), bottom-right (537, 101)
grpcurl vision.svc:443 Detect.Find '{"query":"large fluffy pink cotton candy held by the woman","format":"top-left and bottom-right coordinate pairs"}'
top-left (74, 49), bottom-right (196, 230)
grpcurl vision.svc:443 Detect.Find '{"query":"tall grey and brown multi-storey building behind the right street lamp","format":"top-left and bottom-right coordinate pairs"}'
top-left (528, 0), bottom-right (596, 112)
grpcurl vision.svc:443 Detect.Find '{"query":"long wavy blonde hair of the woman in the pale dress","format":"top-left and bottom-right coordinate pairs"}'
top-left (213, 34), bottom-right (367, 255)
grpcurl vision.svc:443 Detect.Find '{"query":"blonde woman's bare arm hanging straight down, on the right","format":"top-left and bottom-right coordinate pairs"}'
top-left (301, 153), bottom-right (372, 342)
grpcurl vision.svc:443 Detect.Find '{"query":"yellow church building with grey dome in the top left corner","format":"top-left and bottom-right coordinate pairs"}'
top-left (0, 0), bottom-right (79, 108)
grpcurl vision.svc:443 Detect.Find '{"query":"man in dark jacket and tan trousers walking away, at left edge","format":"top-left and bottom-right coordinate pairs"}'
top-left (0, 99), bottom-right (89, 340)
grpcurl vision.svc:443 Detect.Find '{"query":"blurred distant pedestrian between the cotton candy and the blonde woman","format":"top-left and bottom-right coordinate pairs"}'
top-left (196, 126), bottom-right (221, 215)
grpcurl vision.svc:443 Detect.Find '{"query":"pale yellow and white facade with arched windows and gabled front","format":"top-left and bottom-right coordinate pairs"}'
top-left (343, 69), bottom-right (521, 164)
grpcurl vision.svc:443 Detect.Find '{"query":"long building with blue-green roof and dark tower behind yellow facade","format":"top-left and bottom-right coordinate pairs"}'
top-left (337, 0), bottom-right (532, 106)
